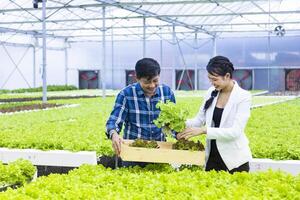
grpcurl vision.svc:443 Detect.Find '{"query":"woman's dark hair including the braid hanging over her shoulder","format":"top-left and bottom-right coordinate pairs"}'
top-left (204, 56), bottom-right (234, 111)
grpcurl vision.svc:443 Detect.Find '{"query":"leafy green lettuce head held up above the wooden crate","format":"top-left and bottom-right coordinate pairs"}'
top-left (153, 101), bottom-right (188, 136)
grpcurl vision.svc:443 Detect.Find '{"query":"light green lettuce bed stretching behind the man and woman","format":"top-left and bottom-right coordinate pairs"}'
top-left (0, 97), bottom-right (300, 160)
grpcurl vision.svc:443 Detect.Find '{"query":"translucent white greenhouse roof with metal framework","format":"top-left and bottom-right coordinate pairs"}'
top-left (0, 0), bottom-right (300, 42)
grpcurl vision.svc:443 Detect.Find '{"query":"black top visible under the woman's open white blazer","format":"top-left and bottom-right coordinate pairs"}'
top-left (209, 107), bottom-right (224, 159)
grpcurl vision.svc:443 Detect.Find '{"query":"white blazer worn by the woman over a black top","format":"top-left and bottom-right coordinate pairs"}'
top-left (186, 81), bottom-right (252, 170)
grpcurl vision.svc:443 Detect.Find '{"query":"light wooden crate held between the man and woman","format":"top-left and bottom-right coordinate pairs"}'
top-left (120, 140), bottom-right (205, 165)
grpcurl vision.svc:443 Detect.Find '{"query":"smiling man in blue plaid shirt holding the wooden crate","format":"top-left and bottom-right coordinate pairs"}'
top-left (106, 58), bottom-right (175, 166)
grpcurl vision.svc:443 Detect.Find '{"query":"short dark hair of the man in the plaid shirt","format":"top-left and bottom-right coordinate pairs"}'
top-left (135, 58), bottom-right (160, 80)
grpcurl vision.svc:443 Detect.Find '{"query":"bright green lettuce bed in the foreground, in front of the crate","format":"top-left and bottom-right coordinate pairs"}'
top-left (0, 165), bottom-right (300, 200)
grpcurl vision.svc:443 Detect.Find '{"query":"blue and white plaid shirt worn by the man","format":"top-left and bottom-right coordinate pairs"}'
top-left (106, 83), bottom-right (175, 141)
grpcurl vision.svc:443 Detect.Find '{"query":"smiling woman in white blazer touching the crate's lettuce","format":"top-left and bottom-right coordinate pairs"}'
top-left (177, 56), bottom-right (252, 173)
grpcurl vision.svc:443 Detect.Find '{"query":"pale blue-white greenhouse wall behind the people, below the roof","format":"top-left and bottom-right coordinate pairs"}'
top-left (0, 37), bottom-right (300, 91)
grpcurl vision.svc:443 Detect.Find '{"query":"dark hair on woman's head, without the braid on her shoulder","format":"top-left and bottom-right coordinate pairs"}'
top-left (206, 56), bottom-right (234, 78)
